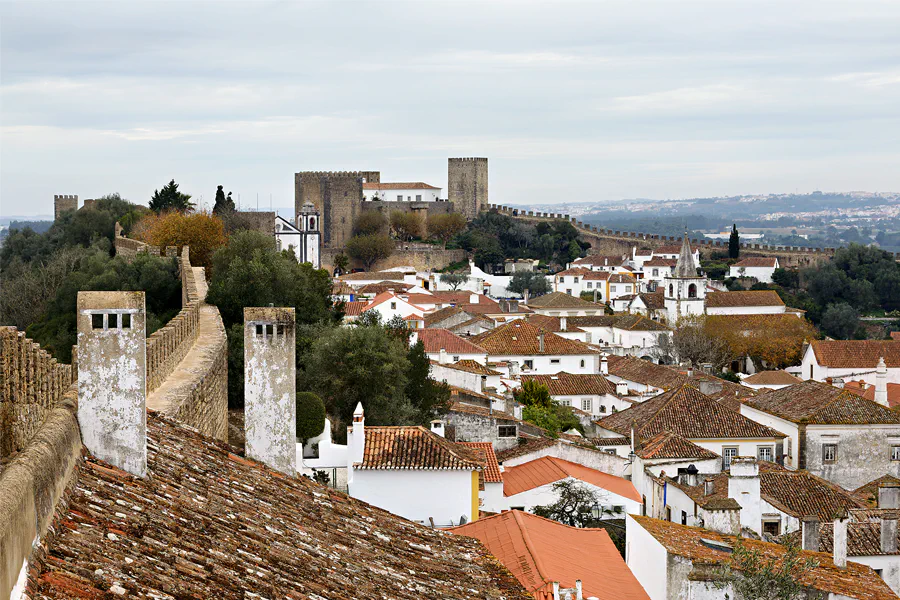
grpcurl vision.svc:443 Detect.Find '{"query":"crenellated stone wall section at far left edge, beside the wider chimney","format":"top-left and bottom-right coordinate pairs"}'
top-left (0, 327), bottom-right (75, 461)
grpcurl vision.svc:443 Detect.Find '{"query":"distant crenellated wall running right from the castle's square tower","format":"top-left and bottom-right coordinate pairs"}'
top-left (488, 204), bottom-right (900, 267)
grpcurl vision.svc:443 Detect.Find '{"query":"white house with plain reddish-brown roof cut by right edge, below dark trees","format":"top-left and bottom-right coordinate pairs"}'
top-left (800, 340), bottom-right (900, 385)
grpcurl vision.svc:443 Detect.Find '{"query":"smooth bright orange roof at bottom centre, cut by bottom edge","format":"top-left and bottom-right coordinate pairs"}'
top-left (449, 510), bottom-right (649, 600)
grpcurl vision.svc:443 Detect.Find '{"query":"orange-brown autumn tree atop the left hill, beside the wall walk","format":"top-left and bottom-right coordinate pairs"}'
top-left (132, 211), bottom-right (226, 275)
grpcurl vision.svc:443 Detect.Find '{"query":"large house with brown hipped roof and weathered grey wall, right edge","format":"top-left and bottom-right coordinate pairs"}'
top-left (740, 381), bottom-right (900, 489)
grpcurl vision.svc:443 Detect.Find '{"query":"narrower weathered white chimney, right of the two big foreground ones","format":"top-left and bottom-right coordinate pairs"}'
top-left (244, 307), bottom-right (297, 475)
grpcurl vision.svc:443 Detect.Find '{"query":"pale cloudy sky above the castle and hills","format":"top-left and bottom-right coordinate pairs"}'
top-left (0, 0), bottom-right (900, 216)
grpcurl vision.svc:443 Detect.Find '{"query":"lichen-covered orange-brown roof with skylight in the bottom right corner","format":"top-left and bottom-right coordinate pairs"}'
top-left (629, 515), bottom-right (897, 600)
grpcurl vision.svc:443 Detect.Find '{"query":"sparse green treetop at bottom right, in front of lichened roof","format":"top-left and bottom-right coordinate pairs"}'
top-left (715, 536), bottom-right (822, 600)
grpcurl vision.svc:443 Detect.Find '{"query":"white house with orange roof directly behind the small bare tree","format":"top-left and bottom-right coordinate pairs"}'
top-left (503, 456), bottom-right (641, 518)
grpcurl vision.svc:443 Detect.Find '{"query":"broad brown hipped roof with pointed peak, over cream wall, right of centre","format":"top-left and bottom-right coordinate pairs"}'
top-left (597, 384), bottom-right (785, 440)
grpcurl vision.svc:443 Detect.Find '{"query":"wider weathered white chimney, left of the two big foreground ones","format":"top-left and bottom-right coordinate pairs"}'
top-left (76, 292), bottom-right (147, 477)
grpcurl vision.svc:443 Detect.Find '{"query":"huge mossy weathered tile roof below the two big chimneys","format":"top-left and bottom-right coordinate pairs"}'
top-left (28, 412), bottom-right (530, 600)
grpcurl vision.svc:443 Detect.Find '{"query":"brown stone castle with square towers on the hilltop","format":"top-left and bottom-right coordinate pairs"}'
top-left (294, 158), bottom-right (488, 248)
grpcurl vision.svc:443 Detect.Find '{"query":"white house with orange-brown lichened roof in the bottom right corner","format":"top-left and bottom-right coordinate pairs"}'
top-left (625, 515), bottom-right (896, 600)
